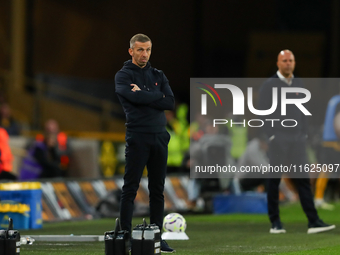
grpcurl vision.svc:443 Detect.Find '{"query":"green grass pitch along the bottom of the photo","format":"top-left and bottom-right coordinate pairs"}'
top-left (20, 204), bottom-right (340, 255)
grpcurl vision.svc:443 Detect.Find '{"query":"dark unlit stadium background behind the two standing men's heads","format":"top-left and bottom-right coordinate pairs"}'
top-left (0, 0), bottom-right (340, 127)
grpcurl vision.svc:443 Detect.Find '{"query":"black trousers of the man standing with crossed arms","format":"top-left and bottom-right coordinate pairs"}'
top-left (120, 131), bottom-right (170, 233)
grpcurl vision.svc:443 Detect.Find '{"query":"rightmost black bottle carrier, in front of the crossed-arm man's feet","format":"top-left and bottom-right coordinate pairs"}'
top-left (131, 219), bottom-right (161, 255)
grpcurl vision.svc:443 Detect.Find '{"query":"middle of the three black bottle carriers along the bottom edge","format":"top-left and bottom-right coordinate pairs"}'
top-left (104, 218), bottom-right (130, 255)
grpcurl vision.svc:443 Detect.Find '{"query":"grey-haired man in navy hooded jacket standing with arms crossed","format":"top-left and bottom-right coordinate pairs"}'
top-left (115, 34), bottom-right (175, 253)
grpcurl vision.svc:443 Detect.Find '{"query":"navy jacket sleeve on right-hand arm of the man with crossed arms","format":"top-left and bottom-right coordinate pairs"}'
top-left (149, 73), bottom-right (175, 111)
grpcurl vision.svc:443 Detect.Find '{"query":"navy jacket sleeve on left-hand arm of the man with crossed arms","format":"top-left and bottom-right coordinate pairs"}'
top-left (115, 71), bottom-right (163, 105)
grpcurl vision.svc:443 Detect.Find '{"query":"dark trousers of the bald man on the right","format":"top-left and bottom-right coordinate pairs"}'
top-left (267, 133), bottom-right (319, 223)
